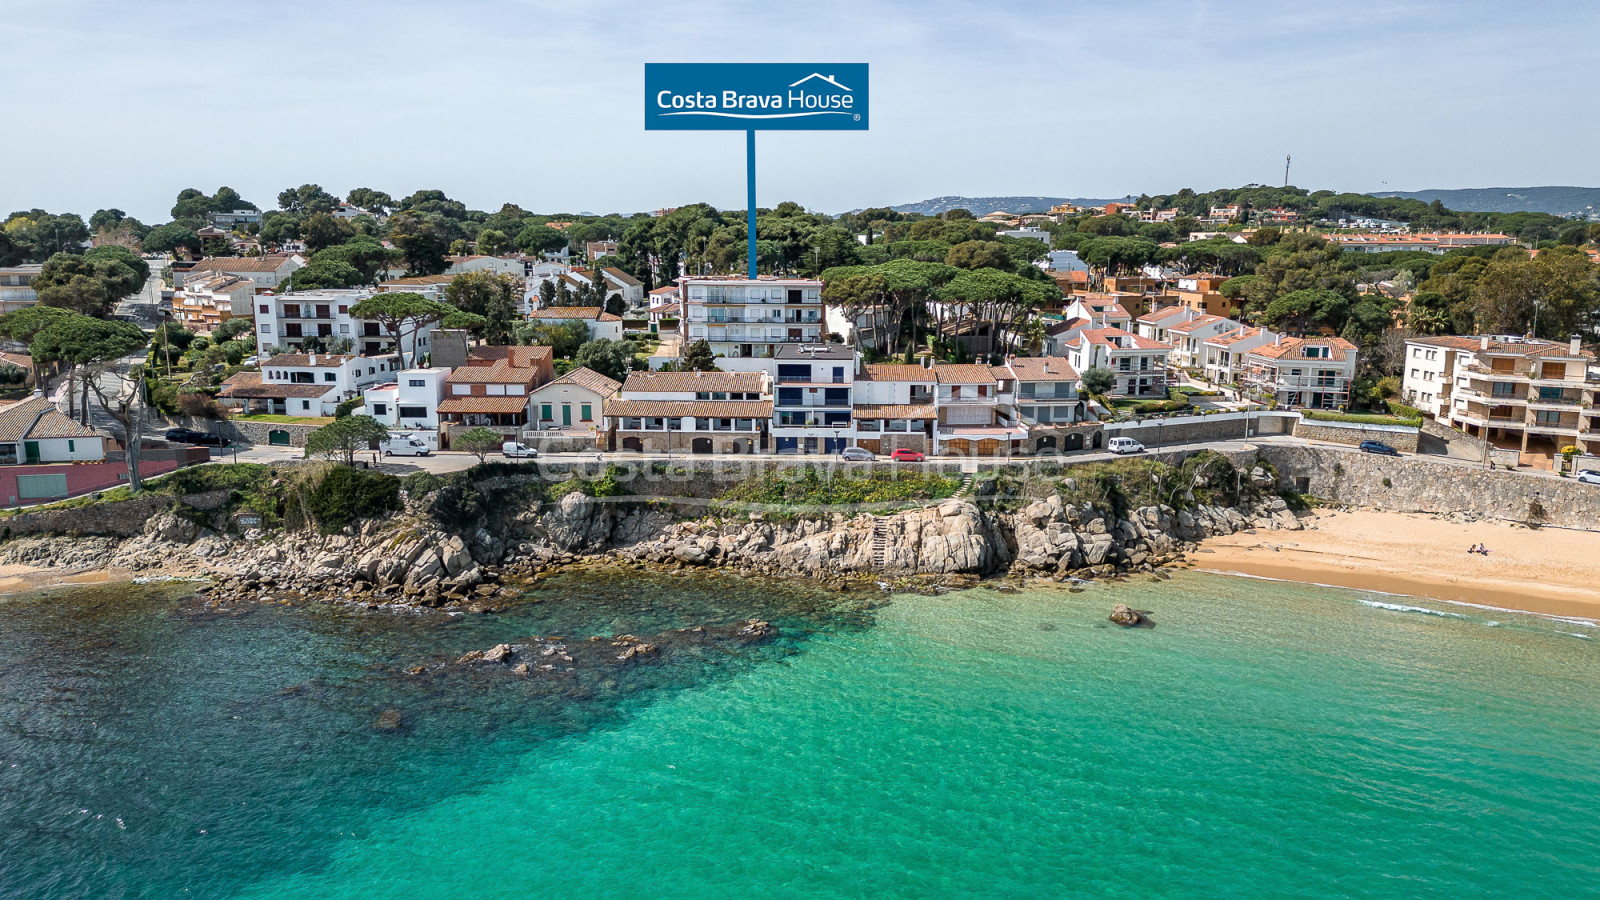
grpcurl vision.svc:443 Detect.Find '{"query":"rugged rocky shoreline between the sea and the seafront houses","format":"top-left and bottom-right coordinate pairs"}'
top-left (0, 464), bottom-right (1301, 612)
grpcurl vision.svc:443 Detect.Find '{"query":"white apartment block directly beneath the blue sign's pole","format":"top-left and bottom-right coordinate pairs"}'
top-left (678, 275), bottom-right (824, 357)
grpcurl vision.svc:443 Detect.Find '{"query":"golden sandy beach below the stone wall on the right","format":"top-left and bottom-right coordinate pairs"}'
top-left (1190, 511), bottom-right (1600, 620)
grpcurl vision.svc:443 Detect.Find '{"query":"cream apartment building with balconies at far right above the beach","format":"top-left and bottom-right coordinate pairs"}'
top-left (1400, 335), bottom-right (1600, 458)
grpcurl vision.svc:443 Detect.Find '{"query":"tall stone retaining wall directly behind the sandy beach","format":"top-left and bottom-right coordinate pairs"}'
top-left (1259, 445), bottom-right (1600, 532)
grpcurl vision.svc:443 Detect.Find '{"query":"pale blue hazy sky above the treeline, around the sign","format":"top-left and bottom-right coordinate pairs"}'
top-left (0, 0), bottom-right (1600, 223)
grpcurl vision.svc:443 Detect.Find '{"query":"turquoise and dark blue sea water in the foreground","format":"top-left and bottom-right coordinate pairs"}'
top-left (0, 573), bottom-right (1600, 900)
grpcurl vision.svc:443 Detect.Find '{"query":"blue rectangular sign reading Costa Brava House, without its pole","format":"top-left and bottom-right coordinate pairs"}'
top-left (645, 62), bottom-right (867, 131)
